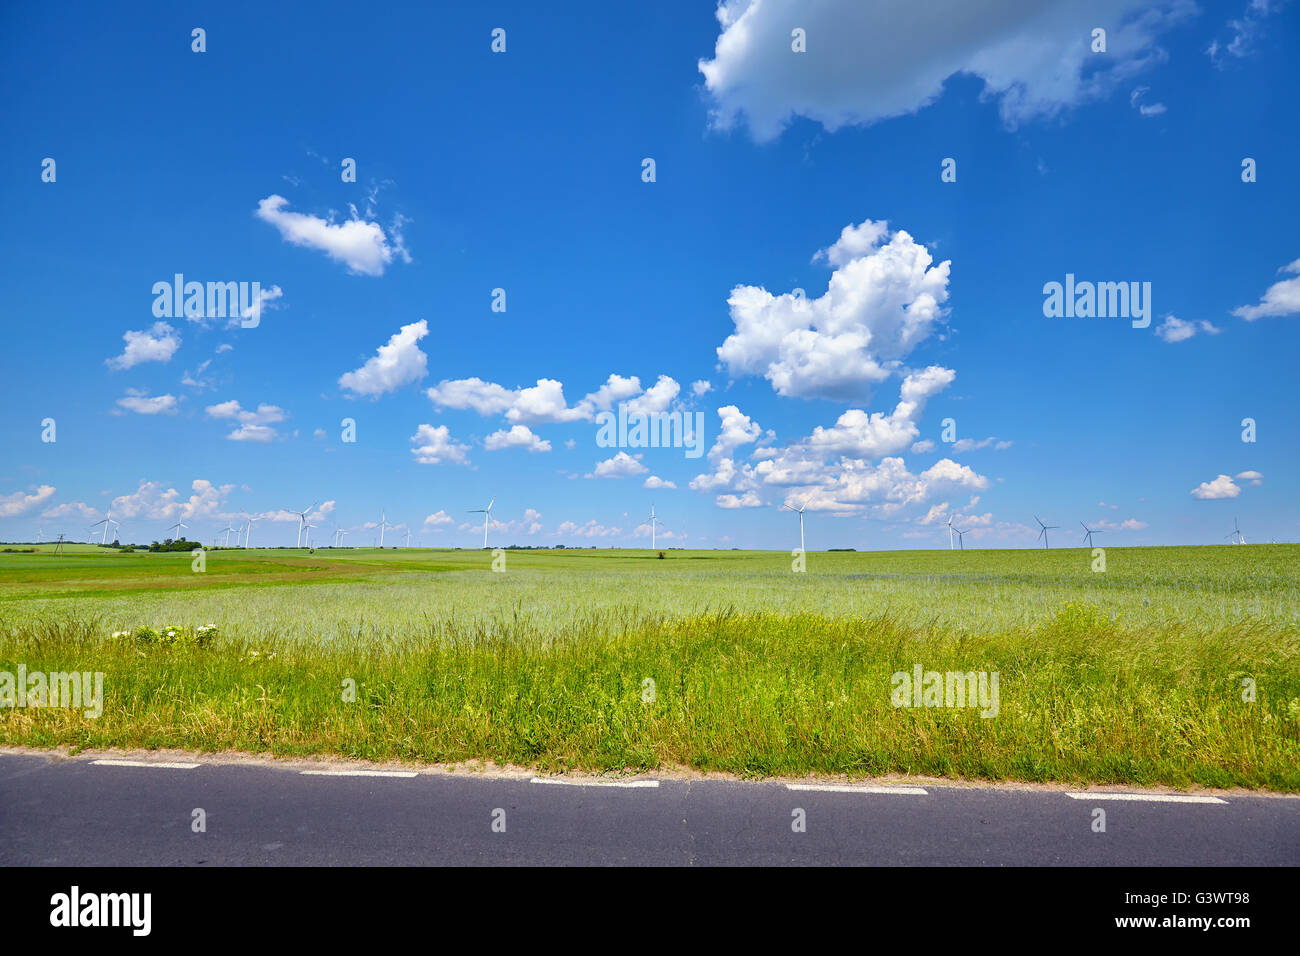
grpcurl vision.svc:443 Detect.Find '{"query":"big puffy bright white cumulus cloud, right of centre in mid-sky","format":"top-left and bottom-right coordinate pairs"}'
top-left (718, 220), bottom-right (950, 401)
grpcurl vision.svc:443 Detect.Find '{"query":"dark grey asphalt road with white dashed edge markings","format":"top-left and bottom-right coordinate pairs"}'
top-left (0, 753), bottom-right (1300, 866)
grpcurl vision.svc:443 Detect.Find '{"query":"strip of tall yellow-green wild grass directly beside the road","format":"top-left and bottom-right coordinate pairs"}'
top-left (0, 613), bottom-right (1300, 792)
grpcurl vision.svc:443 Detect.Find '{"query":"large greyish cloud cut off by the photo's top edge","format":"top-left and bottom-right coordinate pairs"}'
top-left (699, 0), bottom-right (1196, 142)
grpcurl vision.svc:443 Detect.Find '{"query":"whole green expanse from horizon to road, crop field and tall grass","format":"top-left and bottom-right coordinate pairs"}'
top-left (0, 545), bottom-right (1300, 791)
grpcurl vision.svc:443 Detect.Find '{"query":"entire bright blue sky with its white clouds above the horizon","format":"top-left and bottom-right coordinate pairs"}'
top-left (0, 0), bottom-right (1300, 550)
